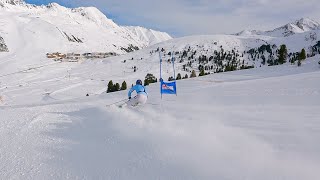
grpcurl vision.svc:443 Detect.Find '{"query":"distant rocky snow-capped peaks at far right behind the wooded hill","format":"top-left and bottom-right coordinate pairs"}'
top-left (236, 18), bottom-right (320, 37)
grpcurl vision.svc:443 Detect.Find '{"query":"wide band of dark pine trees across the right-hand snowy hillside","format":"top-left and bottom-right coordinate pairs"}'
top-left (150, 41), bottom-right (320, 81)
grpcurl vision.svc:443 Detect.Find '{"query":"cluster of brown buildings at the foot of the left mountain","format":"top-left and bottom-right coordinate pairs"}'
top-left (47, 52), bottom-right (117, 62)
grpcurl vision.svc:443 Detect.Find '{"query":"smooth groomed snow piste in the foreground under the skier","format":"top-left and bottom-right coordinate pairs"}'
top-left (0, 56), bottom-right (320, 180)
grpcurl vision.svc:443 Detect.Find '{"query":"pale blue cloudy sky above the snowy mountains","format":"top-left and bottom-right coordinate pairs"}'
top-left (26, 0), bottom-right (320, 37)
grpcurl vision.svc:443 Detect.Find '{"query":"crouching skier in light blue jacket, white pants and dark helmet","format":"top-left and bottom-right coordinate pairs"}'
top-left (127, 79), bottom-right (148, 106)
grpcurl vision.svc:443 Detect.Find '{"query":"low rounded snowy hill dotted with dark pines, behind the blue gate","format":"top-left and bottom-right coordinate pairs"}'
top-left (109, 30), bottom-right (320, 79)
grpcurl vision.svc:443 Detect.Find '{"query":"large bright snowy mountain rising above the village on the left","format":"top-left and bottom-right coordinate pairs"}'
top-left (0, 0), bottom-right (171, 54)
